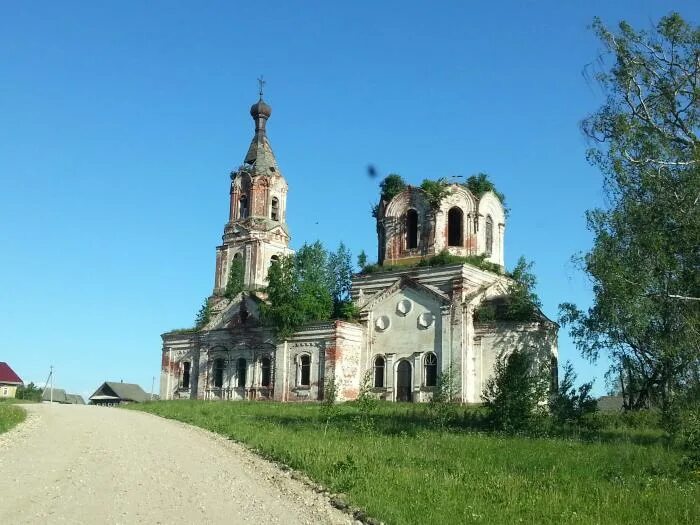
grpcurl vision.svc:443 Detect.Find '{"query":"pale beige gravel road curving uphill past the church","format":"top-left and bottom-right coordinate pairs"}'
top-left (0, 404), bottom-right (352, 525)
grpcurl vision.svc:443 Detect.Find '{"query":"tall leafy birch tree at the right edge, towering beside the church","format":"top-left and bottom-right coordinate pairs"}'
top-left (560, 13), bottom-right (700, 412)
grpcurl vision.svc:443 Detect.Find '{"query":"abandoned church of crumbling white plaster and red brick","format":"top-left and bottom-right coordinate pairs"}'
top-left (160, 95), bottom-right (558, 403)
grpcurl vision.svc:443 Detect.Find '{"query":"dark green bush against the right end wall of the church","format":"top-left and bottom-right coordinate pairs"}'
top-left (481, 349), bottom-right (548, 433)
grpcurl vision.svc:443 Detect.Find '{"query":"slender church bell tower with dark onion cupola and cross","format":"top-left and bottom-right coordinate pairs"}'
top-left (214, 89), bottom-right (291, 295)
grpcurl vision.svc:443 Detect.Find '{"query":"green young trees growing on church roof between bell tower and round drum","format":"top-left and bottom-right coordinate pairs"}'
top-left (260, 241), bottom-right (333, 338)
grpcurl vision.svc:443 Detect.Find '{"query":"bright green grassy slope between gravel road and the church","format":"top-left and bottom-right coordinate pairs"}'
top-left (130, 401), bottom-right (700, 524)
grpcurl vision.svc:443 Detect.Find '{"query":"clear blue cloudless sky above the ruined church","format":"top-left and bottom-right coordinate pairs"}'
top-left (0, 0), bottom-right (700, 395)
